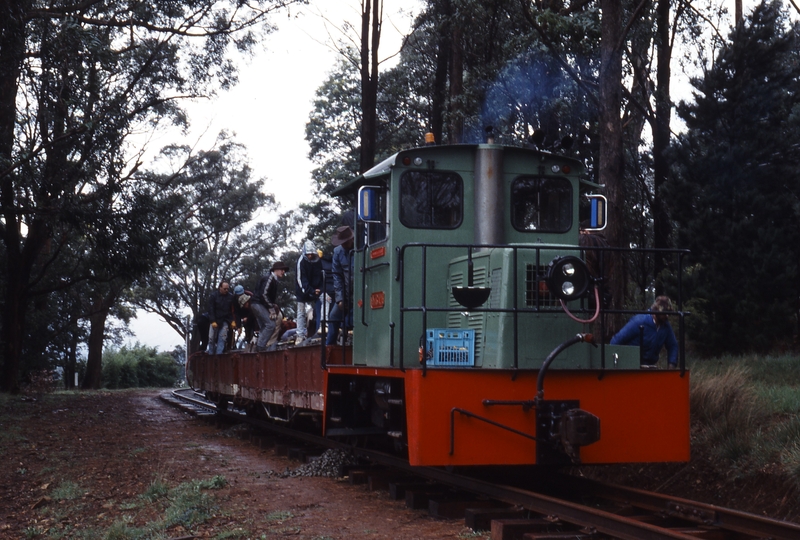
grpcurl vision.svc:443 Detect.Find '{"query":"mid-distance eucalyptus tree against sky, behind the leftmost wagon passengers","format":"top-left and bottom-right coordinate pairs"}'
top-left (131, 137), bottom-right (282, 346)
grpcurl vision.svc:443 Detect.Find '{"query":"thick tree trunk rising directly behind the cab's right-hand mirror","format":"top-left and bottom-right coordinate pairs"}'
top-left (598, 0), bottom-right (626, 328)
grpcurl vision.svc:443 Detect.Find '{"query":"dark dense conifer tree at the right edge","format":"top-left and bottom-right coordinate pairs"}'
top-left (668, 2), bottom-right (800, 353)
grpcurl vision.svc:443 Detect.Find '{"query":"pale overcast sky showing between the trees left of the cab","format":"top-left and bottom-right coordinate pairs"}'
top-left (125, 0), bottom-right (418, 351)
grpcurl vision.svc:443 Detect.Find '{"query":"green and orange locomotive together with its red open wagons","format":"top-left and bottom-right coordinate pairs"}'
top-left (187, 136), bottom-right (689, 466)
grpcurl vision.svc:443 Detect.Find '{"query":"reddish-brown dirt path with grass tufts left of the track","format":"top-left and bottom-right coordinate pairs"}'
top-left (0, 391), bottom-right (474, 540)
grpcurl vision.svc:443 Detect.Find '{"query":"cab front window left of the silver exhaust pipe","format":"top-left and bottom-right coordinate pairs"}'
top-left (400, 171), bottom-right (464, 229)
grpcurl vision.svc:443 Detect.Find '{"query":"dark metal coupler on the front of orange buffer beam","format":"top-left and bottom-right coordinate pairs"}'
top-left (536, 400), bottom-right (600, 465)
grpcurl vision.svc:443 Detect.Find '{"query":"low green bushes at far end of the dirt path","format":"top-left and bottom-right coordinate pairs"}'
top-left (103, 344), bottom-right (181, 389)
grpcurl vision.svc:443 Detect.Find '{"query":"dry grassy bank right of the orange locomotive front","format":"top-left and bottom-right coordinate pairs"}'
top-left (691, 355), bottom-right (800, 486)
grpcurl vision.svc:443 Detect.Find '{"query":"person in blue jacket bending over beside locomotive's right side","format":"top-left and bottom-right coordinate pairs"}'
top-left (611, 296), bottom-right (678, 368)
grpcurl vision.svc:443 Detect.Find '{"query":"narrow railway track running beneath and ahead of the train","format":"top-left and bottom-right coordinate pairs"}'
top-left (172, 389), bottom-right (800, 540)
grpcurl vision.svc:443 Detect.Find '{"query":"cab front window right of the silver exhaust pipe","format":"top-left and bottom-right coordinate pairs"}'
top-left (511, 176), bottom-right (572, 233)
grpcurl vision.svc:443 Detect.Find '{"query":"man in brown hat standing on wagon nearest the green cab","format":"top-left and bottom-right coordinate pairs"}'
top-left (325, 225), bottom-right (354, 345)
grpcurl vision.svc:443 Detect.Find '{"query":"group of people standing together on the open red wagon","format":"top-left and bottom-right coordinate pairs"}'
top-left (195, 225), bottom-right (354, 354)
